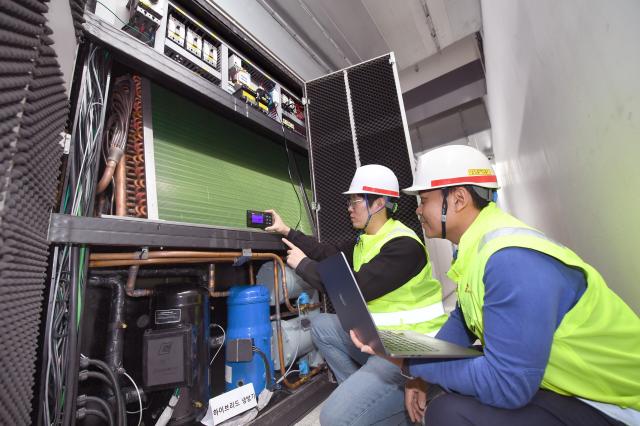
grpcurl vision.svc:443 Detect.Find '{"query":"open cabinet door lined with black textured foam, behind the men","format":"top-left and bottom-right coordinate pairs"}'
top-left (305, 53), bottom-right (422, 243)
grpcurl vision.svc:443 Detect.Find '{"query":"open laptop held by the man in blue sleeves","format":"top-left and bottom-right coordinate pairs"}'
top-left (318, 252), bottom-right (482, 359)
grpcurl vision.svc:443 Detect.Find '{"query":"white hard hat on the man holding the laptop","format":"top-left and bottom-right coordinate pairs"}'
top-left (402, 145), bottom-right (498, 195)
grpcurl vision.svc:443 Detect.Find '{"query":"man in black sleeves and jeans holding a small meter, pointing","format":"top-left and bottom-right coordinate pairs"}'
top-left (267, 164), bottom-right (446, 426)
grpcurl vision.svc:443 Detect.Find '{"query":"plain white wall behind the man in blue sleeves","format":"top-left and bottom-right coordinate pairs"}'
top-left (482, 0), bottom-right (640, 312)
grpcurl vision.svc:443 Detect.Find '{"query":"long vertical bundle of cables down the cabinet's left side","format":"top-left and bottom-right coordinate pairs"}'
top-left (41, 45), bottom-right (112, 425)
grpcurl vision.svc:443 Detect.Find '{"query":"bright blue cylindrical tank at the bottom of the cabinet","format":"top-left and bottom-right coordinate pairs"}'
top-left (225, 286), bottom-right (273, 395)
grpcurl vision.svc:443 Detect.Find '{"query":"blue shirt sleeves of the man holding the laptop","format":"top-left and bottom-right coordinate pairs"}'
top-left (409, 247), bottom-right (586, 408)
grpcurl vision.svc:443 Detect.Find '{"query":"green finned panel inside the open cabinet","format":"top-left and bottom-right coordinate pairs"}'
top-left (151, 85), bottom-right (311, 233)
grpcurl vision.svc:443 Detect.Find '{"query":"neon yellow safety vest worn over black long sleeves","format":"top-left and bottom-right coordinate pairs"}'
top-left (353, 219), bottom-right (447, 334)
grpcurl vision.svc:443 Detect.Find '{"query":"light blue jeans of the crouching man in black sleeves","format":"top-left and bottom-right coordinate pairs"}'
top-left (311, 314), bottom-right (411, 426)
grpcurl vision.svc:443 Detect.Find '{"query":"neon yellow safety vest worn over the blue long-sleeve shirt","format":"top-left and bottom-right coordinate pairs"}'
top-left (448, 203), bottom-right (640, 410)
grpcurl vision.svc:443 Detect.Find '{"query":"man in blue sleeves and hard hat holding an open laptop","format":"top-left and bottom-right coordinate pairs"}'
top-left (352, 145), bottom-right (640, 426)
